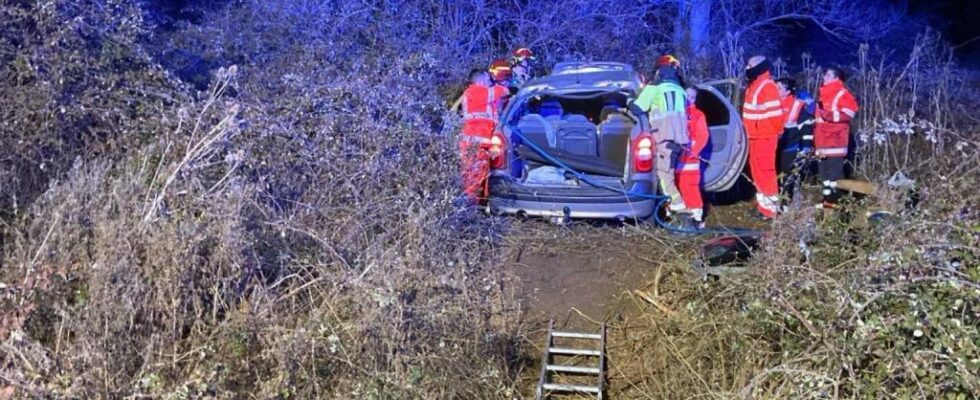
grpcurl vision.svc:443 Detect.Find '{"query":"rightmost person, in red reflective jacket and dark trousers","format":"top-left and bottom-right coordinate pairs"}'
top-left (813, 67), bottom-right (858, 208)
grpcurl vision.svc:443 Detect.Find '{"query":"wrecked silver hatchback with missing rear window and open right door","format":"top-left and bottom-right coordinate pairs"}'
top-left (486, 62), bottom-right (748, 221)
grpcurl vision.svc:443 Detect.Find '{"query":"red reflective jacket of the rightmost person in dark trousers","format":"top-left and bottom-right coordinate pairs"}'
top-left (813, 80), bottom-right (858, 157)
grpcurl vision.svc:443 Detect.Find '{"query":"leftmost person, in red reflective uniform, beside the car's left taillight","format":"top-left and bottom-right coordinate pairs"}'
top-left (459, 69), bottom-right (507, 204)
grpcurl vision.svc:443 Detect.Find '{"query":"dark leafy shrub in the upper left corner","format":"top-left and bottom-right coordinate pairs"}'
top-left (0, 0), bottom-right (181, 222)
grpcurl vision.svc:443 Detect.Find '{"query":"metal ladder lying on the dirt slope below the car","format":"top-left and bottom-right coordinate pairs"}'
top-left (535, 320), bottom-right (606, 400)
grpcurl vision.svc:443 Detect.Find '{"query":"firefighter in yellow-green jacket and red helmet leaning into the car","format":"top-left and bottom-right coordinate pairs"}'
top-left (629, 54), bottom-right (689, 213)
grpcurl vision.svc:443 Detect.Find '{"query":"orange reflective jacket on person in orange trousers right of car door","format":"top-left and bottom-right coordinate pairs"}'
top-left (742, 72), bottom-right (784, 139)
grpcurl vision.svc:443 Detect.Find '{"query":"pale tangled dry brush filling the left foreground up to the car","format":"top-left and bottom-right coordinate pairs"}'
top-left (0, 2), bottom-right (524, 398)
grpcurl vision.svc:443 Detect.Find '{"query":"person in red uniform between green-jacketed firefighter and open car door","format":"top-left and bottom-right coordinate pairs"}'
top-left (677, 87), bottom-right (709, 229)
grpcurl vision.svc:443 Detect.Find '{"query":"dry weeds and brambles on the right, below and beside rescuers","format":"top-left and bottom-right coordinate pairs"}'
top-left (611, 36), bottom-right (980, 399)
